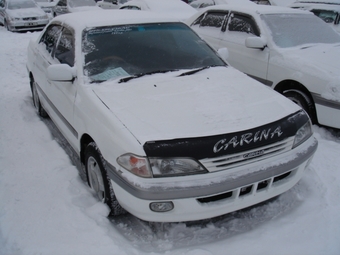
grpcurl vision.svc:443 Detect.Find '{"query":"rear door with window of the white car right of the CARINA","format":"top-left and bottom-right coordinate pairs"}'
top-left (191, 11), bottom-right (228, 50)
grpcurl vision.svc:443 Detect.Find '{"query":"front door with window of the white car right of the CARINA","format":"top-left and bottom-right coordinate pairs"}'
top-left (218, 11), bottom-right (270, 85)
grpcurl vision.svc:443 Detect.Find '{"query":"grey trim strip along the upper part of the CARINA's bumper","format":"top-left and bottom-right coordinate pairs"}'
top-left (106, 138), bottom-right (318, 200)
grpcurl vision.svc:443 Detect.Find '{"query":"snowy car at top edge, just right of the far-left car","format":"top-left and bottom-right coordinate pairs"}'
top-left (53, 0), bottom-right (102, 17)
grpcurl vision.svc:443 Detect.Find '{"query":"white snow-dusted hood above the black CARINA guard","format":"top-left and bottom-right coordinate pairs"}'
top-left (93, 67), bottom-right (300, 144)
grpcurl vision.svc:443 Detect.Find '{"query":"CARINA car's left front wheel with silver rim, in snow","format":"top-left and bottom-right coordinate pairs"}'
top-left (85, 142), bottom-right (126, 216)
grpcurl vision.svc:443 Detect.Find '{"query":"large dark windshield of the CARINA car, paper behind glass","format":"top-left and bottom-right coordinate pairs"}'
top-left (82, 23), bottom-right (226, 82)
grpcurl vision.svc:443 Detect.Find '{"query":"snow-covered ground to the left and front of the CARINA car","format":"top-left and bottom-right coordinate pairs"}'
top-left (0, 27), bottom-right (340, 255)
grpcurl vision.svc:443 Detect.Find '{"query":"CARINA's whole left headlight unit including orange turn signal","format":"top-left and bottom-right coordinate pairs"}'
top-left (117, 153), bottom-right (207, 178)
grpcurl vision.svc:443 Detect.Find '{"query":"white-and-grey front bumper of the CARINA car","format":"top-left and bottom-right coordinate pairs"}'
top-left (108, 137), bottom-right (318, 222)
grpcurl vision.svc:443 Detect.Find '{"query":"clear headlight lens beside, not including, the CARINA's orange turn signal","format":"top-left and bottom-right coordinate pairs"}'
top-left (149, 158), bottom-right (207, 177)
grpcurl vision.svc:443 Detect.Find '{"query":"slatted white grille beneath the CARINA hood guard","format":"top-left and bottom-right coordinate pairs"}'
top-left (200, 137), bottom-right (294, 172)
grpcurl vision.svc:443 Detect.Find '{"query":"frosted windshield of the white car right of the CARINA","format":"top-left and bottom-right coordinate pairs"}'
top-left (262, 14), bottom-right (340, 48)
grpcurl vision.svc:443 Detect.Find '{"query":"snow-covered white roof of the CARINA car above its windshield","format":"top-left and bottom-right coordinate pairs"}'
top-left (52, 10), bottom-right (179, 30)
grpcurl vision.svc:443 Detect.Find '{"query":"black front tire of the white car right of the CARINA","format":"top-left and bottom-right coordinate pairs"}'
top-left (283, 89), bottom-right (317, 124)
